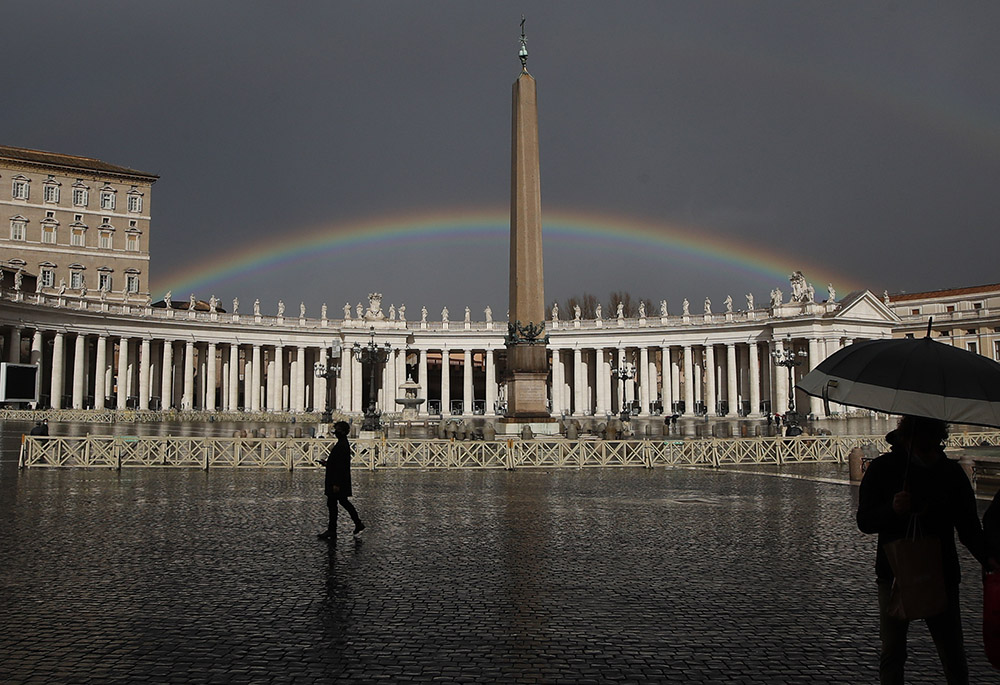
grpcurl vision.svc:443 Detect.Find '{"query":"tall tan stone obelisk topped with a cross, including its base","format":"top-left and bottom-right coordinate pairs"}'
top-left (506, 17), bottom-right (550, 423)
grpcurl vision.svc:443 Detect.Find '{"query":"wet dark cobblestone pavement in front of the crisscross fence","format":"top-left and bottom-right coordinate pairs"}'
top-left (0, 424), bottom-right (997, 683)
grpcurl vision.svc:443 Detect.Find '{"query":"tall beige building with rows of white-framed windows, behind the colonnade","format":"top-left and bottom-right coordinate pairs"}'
top-left (0, 146), bottom-right (158, 301)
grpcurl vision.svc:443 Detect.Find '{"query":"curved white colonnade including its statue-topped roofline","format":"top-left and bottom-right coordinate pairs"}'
top-left (0, 287), bottom-right (900, 417)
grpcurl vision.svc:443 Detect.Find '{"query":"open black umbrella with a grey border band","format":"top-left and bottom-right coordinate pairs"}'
top-left (797, 338), bottom-right (1000, 426)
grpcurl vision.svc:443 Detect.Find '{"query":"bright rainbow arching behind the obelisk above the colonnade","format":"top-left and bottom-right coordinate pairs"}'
top-left (151, 209), bottom-right (857, 297)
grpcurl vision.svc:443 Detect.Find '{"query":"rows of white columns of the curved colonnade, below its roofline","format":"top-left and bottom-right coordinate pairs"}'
top-left (5, 326), bottom-right (853, 417)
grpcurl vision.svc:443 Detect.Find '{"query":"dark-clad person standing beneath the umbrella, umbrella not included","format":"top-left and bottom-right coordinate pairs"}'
top-left (858, 416), bottom-right (986, 683)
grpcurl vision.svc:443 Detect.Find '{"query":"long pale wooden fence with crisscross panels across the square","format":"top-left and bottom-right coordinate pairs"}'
top-left (19, 432), bottom-right (1000, 471)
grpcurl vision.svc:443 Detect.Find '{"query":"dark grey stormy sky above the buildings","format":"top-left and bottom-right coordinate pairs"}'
top-left (0, 0), bottom-right (1000, 318)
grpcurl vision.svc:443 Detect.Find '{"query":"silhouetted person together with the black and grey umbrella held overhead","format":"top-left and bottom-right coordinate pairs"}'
top-left (797, 321), bottom-right (1000, 683)
